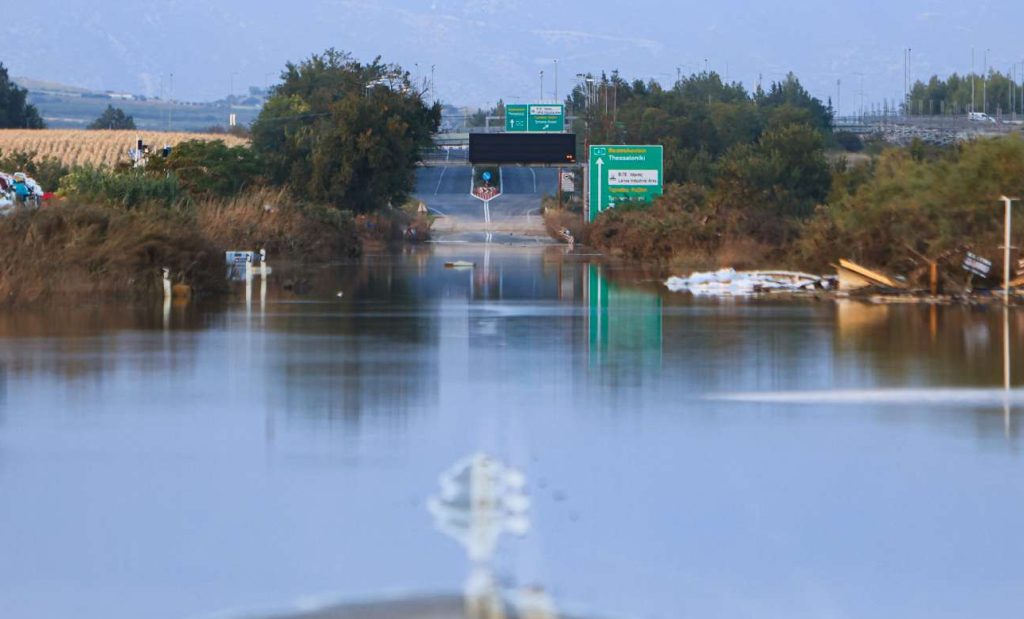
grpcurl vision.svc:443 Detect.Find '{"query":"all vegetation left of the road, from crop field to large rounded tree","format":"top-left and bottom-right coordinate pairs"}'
top-left (0, 49), bottom-right (440, 303)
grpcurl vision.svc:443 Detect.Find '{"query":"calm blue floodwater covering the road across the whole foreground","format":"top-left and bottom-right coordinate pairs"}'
top-left (0, 244), bottom-right (1024, 619)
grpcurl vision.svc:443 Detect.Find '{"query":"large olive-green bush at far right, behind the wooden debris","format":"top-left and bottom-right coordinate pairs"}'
top-left (793, 135), bottom-right (1024, 271)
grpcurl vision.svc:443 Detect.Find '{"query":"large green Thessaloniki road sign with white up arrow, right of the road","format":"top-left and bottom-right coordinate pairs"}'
top-left (587, 146), bottom-right (665, 221)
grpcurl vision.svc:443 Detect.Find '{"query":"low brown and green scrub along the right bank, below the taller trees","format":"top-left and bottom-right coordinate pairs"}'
top-left (587, 136), bottom-right (1024, 275)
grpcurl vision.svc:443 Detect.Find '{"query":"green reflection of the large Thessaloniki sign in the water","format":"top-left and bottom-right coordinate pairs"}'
top-left (587, 264), bottom-right (662, 369)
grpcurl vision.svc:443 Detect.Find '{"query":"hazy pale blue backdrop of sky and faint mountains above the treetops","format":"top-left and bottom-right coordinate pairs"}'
top-left (8, 0), bottom-right (1024, 111)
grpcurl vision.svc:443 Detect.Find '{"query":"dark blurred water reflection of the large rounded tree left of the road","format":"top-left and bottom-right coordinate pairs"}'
top-left (267, 257), bottom-right (438, 423)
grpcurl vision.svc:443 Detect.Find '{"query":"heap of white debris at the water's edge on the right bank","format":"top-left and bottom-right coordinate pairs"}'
top-left (665, 269), bottom-right (831, 296)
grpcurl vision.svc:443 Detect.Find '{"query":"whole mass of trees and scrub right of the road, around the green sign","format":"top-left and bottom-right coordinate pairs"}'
top-left (561, 74), bottom-right (1024, 280)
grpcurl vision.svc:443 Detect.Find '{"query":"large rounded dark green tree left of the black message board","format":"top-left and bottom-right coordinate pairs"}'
top-left (252, 49), bottom-right (441, 212)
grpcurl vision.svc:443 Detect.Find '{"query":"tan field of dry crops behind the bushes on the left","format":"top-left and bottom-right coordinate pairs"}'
top-left (0, 129), bottom-right (247, 165)
